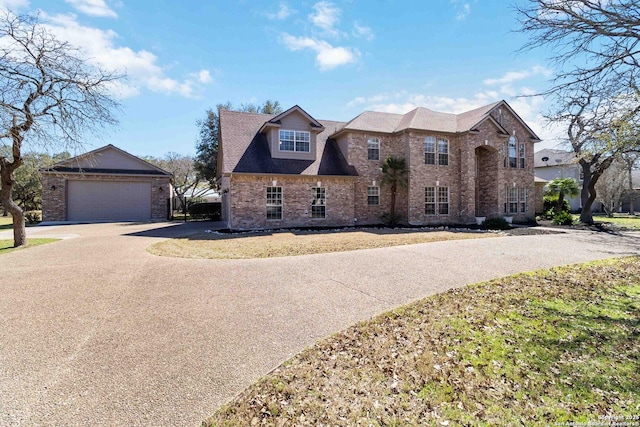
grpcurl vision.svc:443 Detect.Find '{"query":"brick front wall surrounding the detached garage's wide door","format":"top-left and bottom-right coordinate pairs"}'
top-left (42, 173), bottom-right (172, 221)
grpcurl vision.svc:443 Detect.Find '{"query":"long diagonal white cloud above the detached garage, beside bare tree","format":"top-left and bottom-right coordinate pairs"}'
top-left (41, 13), bottom-right (212, 98)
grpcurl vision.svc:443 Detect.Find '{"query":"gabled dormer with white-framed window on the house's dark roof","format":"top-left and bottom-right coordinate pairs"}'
top-left (259, 105), bottom-right (324, 161)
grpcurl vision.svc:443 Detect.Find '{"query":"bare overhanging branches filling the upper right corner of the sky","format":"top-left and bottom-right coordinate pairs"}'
top-left (515, 0), bottom-right (640, 94)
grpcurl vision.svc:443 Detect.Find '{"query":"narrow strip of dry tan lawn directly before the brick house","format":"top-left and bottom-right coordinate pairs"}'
top-left (148, 229), bottom-right (497, 259)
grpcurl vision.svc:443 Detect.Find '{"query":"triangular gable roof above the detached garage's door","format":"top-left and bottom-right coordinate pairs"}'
top-left (50, 144), bottom-right (171, 176)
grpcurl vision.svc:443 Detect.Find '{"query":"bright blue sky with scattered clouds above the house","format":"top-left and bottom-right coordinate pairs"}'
top-left (0, 0), bottom-right (558, 156)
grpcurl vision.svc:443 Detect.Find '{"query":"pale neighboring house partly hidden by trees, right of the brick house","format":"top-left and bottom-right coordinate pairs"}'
top-left (534, 148), bottom-right (602, 212)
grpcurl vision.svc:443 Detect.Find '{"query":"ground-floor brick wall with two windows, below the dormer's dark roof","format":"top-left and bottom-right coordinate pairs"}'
top-left (228, 174), bottom-right (355, 230)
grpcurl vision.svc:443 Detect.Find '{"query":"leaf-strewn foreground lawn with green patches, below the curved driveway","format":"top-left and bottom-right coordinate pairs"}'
top-left (205, 257), bottom-right (640, 426)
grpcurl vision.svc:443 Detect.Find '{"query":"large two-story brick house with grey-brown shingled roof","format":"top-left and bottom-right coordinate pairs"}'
top-left (218, 101), bottom-right (540, 229)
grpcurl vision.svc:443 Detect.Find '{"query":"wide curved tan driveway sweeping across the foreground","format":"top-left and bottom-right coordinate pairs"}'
top-left (0, 223), bottom-right (640, 426)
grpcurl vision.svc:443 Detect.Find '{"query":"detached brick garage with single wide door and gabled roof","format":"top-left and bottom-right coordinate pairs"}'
top-left (42, 145), bottom-right (172, 222)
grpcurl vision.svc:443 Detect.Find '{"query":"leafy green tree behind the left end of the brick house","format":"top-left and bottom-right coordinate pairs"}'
top-left (194, 100), bottom-right (282, 189)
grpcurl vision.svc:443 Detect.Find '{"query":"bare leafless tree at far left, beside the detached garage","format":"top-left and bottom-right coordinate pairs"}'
top-left (0, 12), bottom-right (122, 247)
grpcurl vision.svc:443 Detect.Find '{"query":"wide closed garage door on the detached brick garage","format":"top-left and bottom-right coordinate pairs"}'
top-left (67, 181), bottom-right (151, 221)
